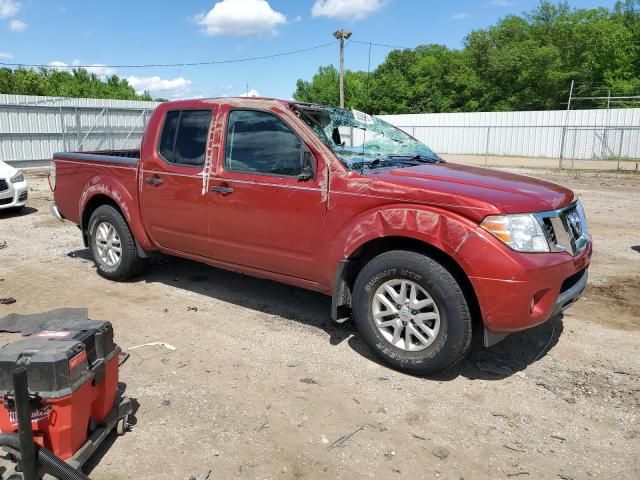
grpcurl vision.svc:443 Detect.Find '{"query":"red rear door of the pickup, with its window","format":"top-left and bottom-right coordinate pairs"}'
top-left (141, 106), bottom-right (217, 256)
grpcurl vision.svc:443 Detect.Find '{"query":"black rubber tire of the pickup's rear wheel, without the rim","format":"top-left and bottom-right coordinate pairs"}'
top-left (89, 205), bottom-right (143, 282)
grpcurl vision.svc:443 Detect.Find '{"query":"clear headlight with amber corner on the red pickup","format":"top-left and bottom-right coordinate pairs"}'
top-left (480, 214), bottom-right (549, 252)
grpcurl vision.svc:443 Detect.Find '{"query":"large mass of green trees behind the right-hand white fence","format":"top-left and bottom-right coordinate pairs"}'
top-left (294, 0), bottom-right (640, 114)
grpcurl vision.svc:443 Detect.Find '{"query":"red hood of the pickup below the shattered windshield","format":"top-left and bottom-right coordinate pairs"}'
top-left (369, 163), bottom-right (575, 217)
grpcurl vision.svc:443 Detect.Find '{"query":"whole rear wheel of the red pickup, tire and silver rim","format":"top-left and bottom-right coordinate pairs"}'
top-left (89, 205), bottom-right (142, 281)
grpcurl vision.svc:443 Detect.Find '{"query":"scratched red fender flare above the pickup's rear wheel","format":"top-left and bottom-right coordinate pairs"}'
top-left (78, 175), bottom-right (155, 251)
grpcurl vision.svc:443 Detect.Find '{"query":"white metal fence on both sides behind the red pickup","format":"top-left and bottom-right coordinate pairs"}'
top-left (0, 94), bottom-right (640, 165)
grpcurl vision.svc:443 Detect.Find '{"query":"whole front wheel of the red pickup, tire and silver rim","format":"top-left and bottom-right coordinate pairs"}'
top-left (353, 250), bottom-right (472, 375)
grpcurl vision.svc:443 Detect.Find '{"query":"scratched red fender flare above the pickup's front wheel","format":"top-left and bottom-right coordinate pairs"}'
top-left (329, 204), bottom-right (477, 283)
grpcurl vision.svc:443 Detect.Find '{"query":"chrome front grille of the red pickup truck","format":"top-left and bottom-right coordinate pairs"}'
top-left (535, 202), bottom-right (589, 255)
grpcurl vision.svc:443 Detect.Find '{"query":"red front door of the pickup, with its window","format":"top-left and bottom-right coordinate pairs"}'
top-left (208, 108), bottom-right (326, 281)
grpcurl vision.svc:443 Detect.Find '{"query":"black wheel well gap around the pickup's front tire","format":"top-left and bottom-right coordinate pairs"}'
top-left (331, 236), bottom-right (482, 322)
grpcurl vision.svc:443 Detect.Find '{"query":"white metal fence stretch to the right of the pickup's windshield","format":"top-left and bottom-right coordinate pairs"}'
top-left (381, 108), bottom-right (640, 159)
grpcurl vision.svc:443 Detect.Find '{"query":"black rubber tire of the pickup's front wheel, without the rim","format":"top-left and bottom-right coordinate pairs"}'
top-left (353, 250), bottom-right (472, 375)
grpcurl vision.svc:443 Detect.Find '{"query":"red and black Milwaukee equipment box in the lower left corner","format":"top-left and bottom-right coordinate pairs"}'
top-left (0, 320), bottom-right (120, 460)
